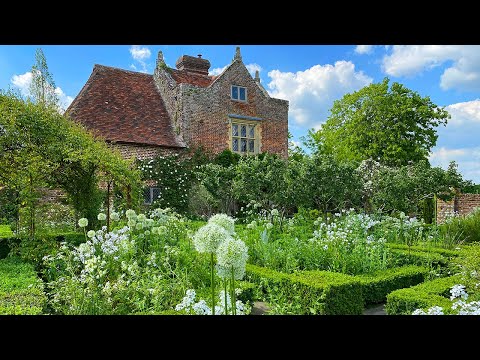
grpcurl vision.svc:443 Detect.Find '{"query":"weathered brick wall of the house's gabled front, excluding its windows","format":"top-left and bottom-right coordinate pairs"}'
top-left (154, 50), bottom-right (288, 158)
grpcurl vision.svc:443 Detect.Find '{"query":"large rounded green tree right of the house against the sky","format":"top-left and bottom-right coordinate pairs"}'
top-left (309, 78), bottom-right (450, 166)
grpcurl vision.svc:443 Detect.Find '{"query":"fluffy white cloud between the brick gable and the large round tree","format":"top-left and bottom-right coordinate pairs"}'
top-left (268, 61), bottom-right (373, 130)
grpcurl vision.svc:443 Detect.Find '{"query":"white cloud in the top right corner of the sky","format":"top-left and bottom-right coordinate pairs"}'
top-left (382, 45), bottom-right (480, 90)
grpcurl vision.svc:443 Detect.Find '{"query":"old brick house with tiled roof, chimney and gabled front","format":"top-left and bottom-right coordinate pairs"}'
top-left (66, 47), bottom-right (288, 204)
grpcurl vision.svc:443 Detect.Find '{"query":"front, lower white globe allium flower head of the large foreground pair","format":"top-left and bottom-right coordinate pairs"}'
top-left (217, 238), bottom-right (248, 280)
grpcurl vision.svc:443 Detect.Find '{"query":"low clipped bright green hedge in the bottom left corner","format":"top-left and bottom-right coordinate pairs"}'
top-left (0, 257), bottom-right (47, 315)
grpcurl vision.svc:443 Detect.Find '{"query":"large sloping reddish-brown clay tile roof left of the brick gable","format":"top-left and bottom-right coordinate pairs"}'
top-left (66, 65), bottom-right (184, 147)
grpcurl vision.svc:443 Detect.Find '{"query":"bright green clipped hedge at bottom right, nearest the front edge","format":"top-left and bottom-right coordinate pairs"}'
top-left (385, 275), bottom-right (460, 315)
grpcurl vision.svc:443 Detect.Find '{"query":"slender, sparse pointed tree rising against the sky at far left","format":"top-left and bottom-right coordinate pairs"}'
top-left (30, 48), bottom-right (59, 106)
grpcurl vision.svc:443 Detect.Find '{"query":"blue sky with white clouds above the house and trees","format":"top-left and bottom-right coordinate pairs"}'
top-left (0, 44), bottom-right (480, 183)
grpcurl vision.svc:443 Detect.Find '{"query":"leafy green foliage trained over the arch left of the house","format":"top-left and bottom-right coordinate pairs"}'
top-left (0, 93), bottom-right (140, 237)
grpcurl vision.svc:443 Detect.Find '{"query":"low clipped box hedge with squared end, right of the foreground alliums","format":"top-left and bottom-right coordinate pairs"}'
top-left (247, 264), bottom-right (363, 315)
